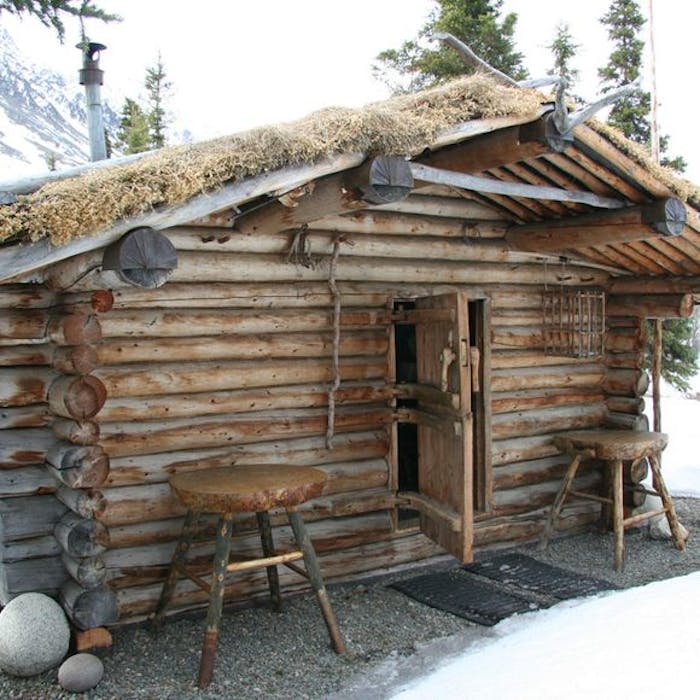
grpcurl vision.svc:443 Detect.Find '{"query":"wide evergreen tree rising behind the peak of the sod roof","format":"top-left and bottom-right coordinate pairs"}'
top-left (373, 0), bottom-right (527, 92)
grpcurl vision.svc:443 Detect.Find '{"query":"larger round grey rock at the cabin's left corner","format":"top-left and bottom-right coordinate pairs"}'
top-left (0, 593), bottom-right (70, 676)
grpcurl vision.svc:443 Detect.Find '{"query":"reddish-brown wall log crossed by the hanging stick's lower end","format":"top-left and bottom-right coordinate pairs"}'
top-left (100, 407), bottom-right (392, 458)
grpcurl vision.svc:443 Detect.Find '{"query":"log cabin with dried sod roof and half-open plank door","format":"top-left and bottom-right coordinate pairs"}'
top-left (0, 75), bottom-right (700, 628)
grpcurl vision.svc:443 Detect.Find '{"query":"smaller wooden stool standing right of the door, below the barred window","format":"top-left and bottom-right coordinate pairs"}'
top-left (541, 430), bottom-right (685, 571)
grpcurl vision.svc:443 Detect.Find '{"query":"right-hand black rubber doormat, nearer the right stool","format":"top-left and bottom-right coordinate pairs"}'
top-left (464, 552), bottom-right (618, 600)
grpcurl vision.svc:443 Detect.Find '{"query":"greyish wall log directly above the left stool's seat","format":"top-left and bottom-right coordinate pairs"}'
top-left (107, 430), bottom-right (389, 493)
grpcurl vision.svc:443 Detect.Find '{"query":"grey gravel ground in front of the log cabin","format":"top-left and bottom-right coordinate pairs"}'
top-left (0, 498), bottom-right (700, 700)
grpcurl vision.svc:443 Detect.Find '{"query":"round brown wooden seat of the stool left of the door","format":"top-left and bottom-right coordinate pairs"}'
top-left (170, 464), bottom-right (326, 513)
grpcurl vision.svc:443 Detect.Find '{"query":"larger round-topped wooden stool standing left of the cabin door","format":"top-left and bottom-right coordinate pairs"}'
top-left (153, 464), bottom-right (345, 688)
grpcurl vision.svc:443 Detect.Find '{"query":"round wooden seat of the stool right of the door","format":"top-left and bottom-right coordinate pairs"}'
top-left (554, 430), bottom-right (668, 460)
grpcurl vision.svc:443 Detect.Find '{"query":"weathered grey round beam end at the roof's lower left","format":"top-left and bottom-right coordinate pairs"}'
top-left (102, 226), bottom-right (177, 289)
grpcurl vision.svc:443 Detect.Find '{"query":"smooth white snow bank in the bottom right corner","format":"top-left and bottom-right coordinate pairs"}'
top-left (390, 572), bottom-right (700, 700)
